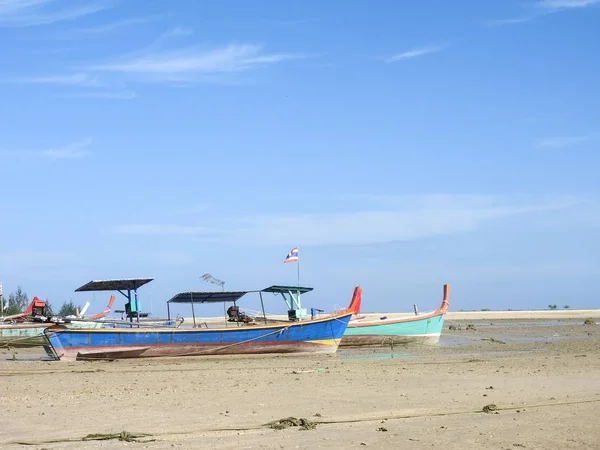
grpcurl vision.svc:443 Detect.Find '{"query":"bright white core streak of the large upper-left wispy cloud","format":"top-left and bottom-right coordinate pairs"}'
top-left (88, 44), bottom-right (305, 81)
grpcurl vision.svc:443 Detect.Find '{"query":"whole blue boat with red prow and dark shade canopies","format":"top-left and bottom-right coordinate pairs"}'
top-left (45, 286), bottom-right (362, 361)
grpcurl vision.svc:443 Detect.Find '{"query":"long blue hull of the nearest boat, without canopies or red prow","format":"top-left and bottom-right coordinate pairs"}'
top-left (45, 312), bottom-right (352, 361)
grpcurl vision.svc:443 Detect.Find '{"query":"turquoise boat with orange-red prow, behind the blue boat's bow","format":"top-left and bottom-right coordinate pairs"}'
top-left (340, 284), bottom-right (450, 346)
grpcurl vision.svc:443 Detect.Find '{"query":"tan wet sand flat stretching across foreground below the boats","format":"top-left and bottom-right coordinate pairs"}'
top-left (0, 319), bottom-right (600, 449)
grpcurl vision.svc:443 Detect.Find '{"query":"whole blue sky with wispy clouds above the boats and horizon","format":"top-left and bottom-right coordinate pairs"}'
top-left (0, 0), bottom-right (600, 315)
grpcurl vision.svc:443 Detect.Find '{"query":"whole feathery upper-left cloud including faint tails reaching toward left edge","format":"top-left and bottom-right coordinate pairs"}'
top-left (5, 30), bottom-right (309, 95)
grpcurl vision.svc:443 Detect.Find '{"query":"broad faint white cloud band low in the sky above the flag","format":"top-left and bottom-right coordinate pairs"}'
top-left (192, 195), bottom-right (574, 245)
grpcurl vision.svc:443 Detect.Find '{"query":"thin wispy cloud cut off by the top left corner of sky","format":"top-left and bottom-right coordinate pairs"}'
top-left (0, 0), bottom-right (107, 27)
